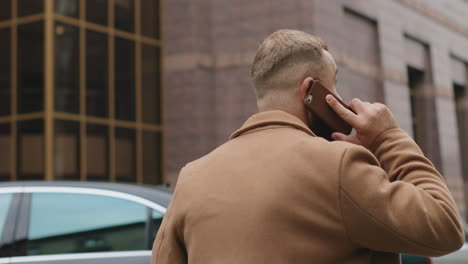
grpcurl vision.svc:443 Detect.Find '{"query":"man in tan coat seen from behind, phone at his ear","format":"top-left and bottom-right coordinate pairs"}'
top-left (152, 30), bottom-right (464, 264)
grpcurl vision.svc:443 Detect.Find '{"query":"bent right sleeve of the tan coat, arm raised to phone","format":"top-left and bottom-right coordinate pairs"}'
top-left (339, 129), bottom-right (464, 256)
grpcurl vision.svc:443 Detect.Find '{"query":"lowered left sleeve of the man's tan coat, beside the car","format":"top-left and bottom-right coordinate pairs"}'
top-left (151, 173), bottom-right (187, 264)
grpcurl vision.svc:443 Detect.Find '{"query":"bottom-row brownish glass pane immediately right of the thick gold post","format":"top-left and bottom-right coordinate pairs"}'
top-left (54, 120), bottom-right (80, 180)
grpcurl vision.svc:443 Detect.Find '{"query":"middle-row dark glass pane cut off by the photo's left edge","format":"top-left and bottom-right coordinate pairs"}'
top-left (0, 28), bottom-right (11, 115)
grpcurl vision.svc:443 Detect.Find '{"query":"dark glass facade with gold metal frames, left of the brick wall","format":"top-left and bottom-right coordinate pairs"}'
top-left (0, 0), bottom-right (164, 184)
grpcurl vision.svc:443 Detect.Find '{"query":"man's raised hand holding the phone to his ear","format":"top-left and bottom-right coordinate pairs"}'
top-left (326, 95), bottom-right (398, 148)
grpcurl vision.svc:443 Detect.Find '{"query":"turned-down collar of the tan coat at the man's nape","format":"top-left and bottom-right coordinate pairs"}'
top-left (229, 110), bottom-right (315, 139)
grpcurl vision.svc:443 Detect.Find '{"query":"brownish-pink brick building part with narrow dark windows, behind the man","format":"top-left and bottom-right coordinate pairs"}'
top-left (163, 0), bottom-right (468, 219)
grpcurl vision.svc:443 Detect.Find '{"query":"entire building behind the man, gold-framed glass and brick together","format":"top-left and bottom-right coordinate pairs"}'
top-left (0, 0), bottom-right (468, 219)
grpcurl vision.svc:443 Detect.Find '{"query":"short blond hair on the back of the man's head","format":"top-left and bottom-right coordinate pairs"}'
top-left (251, 29), bottom-right (327, 99)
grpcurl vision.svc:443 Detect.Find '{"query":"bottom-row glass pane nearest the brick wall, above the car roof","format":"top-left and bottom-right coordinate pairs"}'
top-left (143, 132), bottom-right (162, 185)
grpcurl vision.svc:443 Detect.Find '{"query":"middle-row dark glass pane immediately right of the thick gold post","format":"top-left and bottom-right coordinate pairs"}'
top-left (54, 23), bottom-right (80, 113)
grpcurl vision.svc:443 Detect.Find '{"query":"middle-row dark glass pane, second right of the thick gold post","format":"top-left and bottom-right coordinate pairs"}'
top-left (86, 30), bottom-right (109, 117)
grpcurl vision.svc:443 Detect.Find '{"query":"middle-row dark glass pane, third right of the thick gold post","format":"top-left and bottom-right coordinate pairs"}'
top-left (115, 38), bottom-right (135, 121)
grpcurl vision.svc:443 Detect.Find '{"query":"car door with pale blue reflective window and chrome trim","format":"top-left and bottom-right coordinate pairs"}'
top-left (7, 188), bottom-right (163, 264)
